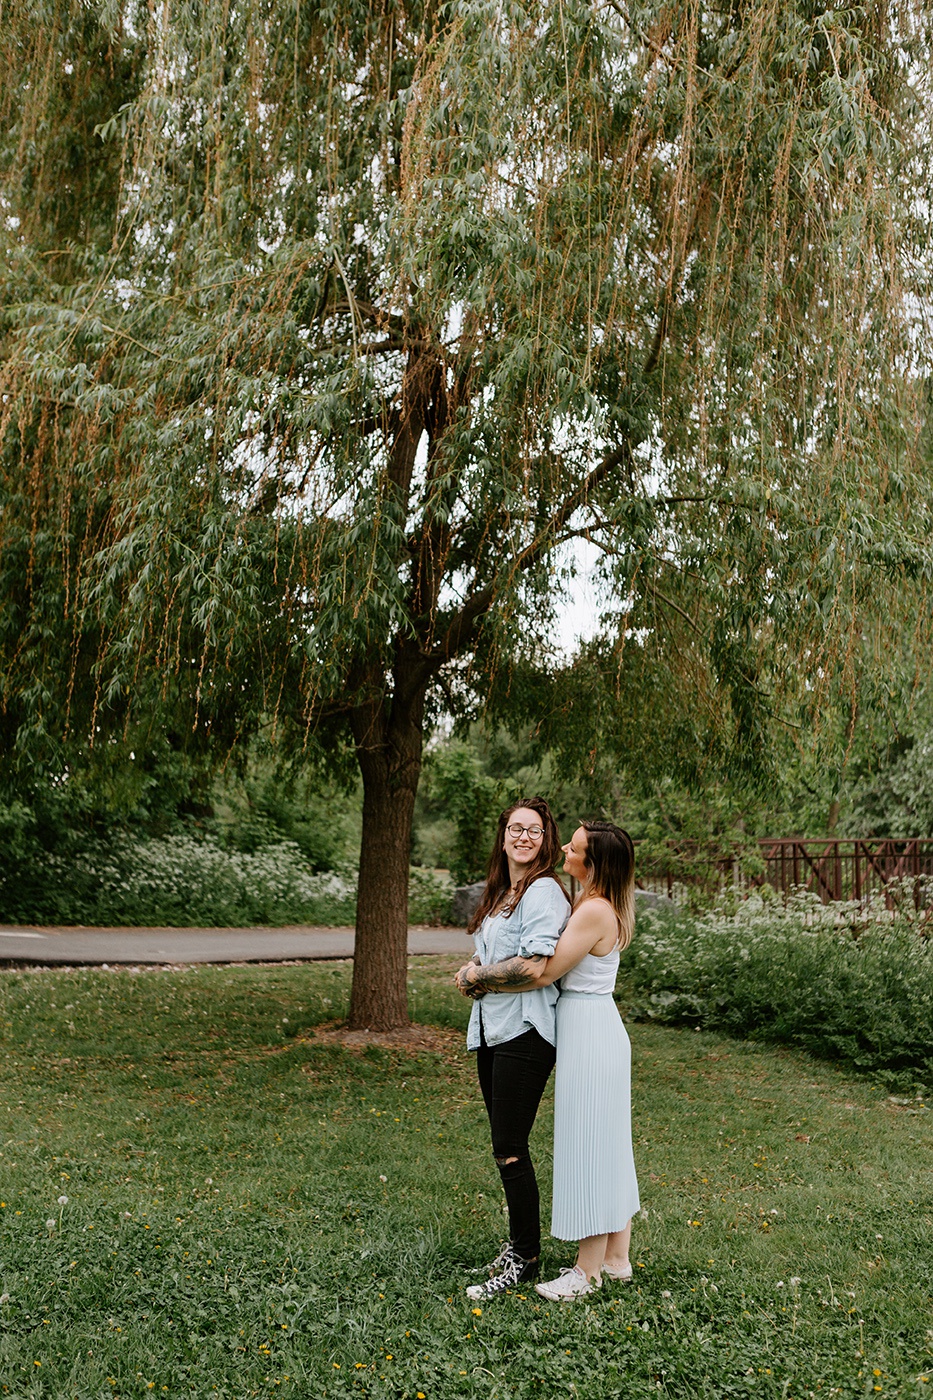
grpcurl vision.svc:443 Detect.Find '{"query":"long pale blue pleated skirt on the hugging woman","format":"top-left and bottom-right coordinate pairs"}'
top-left (551, 991), bottom-right (639, 1239)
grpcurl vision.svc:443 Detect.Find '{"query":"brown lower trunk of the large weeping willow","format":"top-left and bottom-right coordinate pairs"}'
top-left (349, 672), bottom-right (424, 1030)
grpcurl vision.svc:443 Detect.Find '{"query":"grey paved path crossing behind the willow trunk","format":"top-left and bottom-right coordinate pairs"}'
top-left (0, 924), bottom-right (472, 967)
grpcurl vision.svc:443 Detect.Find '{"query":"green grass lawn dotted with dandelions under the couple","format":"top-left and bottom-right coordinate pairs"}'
top-left (0, 958), bottom-right (933, 1400)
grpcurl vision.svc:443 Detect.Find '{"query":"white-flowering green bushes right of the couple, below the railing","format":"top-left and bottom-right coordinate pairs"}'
top-left (628, 888), bottom-right (933, 1084)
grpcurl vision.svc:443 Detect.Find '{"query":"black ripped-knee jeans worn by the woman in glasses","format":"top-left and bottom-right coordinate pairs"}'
top-left (476, 1030), bottom-right (556, 1259)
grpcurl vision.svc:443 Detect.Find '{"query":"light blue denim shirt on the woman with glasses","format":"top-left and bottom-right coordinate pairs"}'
top-left (467, 875), bottom-right (570, 1050)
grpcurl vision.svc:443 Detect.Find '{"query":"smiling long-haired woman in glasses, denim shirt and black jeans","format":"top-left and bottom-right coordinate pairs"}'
top-left (457, 797), bottom-right (570, 1299)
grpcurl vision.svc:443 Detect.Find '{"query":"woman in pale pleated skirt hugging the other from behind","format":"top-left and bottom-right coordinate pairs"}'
top-left (461, 822), bottom-right (639, 1301)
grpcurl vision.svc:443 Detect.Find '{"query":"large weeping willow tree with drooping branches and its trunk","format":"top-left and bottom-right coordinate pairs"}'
top-left (0, 0), bottom-right (930, 1028)
